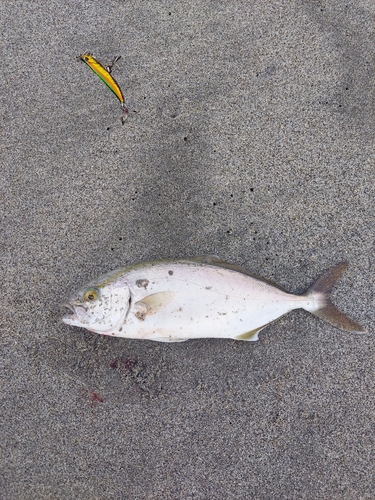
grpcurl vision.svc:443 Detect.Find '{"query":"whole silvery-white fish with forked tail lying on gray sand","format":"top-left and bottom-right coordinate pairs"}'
top-left (63, 256), bottom-right (363, 342)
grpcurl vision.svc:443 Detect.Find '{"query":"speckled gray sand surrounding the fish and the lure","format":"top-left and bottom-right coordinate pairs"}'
top-left (0, 0), bottom-right (375, 500)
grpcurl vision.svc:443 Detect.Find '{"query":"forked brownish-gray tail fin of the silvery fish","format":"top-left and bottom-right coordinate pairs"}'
top-left (302, 261), bottom-right (364, 332)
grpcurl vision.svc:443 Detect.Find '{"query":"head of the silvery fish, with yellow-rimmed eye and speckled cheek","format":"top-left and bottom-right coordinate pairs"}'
top-left (63, 276), bottom-right (131, 335)
